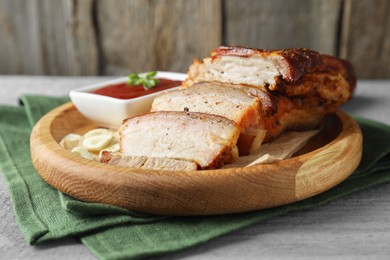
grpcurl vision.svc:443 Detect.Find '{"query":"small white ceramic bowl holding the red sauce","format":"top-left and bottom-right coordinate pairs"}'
top-left (69, 71), bottom-right (187, 129)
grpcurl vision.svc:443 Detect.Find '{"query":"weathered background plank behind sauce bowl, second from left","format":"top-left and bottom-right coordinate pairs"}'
top-left (97, 0), bottom-right (222, 75)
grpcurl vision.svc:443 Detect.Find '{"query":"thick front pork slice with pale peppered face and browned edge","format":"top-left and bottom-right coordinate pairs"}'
top-left (119, 111), bottom-right (240, 169)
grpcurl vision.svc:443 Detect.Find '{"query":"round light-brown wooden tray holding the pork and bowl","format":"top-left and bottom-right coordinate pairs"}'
top-left (30, 103), bottom-right (362, 215)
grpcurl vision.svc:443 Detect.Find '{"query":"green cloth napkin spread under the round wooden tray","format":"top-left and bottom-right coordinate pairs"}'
top-left (0, 96), bottom-right (390, 259)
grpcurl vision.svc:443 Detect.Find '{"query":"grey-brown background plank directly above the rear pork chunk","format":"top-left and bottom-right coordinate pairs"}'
top-left (224, 0), bottom-right (342, 55)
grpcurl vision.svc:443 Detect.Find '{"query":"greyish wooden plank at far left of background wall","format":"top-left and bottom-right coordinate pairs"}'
top-left (0, 0), bottom-right (98, 75)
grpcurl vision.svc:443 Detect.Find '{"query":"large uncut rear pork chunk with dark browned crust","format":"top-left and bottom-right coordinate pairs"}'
top-left (183, 47), bottom-right (356, 142)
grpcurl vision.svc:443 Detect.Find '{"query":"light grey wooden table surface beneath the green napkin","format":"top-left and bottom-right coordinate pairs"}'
top-left (0, 76), bottom-right (390, 259)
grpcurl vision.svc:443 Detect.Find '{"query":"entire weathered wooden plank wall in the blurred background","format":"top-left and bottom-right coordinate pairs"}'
top-left (0, 0), bottom-right (390, 78)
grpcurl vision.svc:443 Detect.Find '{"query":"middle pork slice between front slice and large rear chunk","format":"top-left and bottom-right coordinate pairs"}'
top-left (151, 82), bottom-right (265, 155)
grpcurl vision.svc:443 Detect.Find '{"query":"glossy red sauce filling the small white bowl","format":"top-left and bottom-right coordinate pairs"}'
top-left (92, 78), bottom-right (181, 99)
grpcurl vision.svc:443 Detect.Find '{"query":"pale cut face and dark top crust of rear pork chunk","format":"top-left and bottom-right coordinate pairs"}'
top-left (184, 47), bottom-right (321, 89)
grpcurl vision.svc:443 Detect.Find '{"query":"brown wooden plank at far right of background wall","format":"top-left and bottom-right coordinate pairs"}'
top-left (340, 0), bottom-right (390, 78)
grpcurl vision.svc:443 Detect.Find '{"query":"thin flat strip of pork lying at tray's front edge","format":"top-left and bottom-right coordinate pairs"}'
top-left (100, 151), bottom-right (198, 171)
